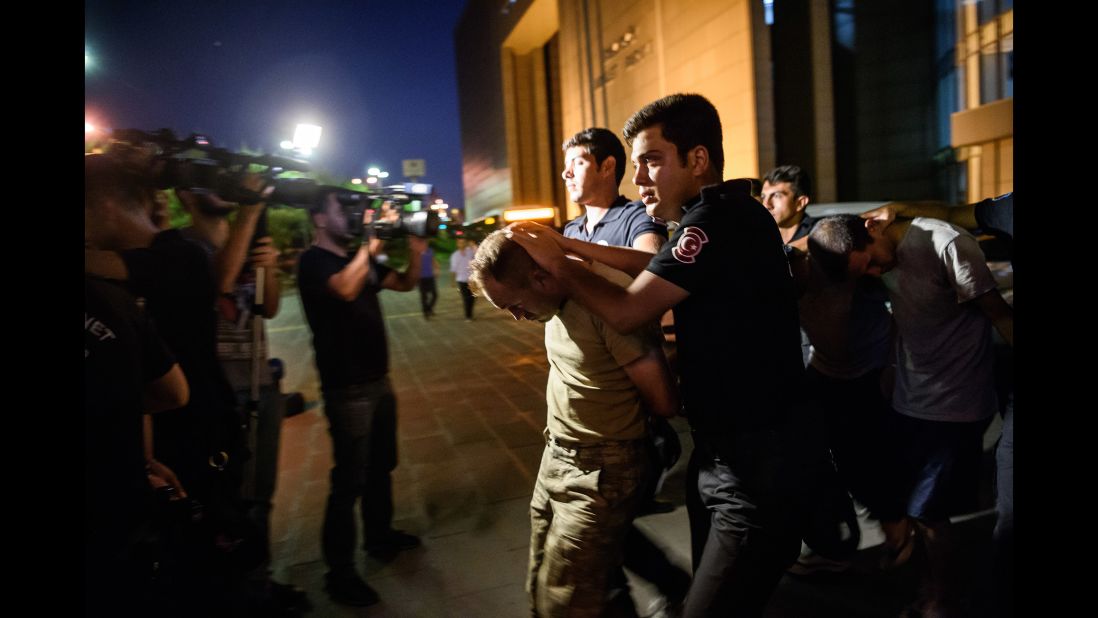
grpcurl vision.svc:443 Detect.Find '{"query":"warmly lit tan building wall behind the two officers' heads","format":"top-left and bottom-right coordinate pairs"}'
top-left (560, 0), bottom-right (759, 196)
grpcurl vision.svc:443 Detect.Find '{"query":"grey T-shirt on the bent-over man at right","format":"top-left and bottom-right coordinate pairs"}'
top-left (883, 217), bottom-right (996, 423)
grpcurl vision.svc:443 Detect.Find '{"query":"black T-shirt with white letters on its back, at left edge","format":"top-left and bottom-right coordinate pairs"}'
top-left (83, 276), bottom-right (176, 543)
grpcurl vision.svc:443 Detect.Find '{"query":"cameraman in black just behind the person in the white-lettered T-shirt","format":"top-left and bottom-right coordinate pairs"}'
top-left (85, 148), bottom-right (270, 615)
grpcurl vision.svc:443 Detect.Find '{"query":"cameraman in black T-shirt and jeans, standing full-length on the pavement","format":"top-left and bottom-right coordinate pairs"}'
top-left (298, 187), bottom-right (427, 606)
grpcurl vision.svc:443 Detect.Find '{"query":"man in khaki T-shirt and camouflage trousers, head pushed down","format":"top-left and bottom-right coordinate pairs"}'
top-left (470, 232), bottom-right (679, 617)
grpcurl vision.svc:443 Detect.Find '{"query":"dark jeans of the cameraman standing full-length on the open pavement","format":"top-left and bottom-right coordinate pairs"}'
top-left (323, 378), bottom-right (396, 572)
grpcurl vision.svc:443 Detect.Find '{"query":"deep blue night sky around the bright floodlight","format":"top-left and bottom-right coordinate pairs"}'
top-left (85, 0), bottom-right (466, 205)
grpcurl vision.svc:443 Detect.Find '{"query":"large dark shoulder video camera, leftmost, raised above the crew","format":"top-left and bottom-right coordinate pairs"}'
top-left (110, 128), bottom-right (309, 204)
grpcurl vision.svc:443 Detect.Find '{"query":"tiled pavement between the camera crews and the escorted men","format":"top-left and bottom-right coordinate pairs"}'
top-left (267, 277), bottom-right (999, 618)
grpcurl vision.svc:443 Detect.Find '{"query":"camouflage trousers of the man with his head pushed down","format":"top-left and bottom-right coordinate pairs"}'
top-left (526, 437), bottom-right (651, 618)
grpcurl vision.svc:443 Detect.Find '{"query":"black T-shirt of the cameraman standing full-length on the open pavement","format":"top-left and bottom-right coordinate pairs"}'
top-left (298, 247), bottom-right (391, 391)
